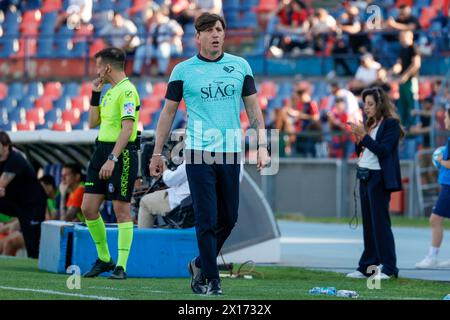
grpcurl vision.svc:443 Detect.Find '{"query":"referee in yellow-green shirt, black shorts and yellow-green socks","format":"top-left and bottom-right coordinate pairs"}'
top-left (81, 48), bottom-right (140, 279)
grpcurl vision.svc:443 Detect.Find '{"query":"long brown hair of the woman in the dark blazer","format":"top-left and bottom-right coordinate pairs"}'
top-left (362, 87), bottom-right (405, 138)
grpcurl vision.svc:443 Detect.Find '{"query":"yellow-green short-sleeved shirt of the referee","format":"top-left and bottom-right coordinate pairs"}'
top-left (98, 78), bottom-right (141, 142)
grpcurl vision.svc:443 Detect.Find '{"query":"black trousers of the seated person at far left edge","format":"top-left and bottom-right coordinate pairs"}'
top-left (0, 197), bottom-right (47, 259)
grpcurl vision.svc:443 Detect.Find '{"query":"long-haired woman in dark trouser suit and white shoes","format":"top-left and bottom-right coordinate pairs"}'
top-left (347, 87), bottom-right (404, 279)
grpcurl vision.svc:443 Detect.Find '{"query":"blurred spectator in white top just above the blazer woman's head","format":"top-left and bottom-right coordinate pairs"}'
top-left (349, 53), bottom-right (381, 95)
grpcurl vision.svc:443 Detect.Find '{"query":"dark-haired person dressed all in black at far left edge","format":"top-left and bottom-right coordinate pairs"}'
top-left (0, 131), bottom-right (47, 259)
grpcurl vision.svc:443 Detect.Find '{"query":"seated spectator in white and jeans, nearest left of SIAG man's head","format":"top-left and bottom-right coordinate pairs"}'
top-left (133, 8), bottom-right (184, 76)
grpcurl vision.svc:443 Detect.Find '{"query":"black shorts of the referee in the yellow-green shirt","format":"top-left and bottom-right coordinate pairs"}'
top-left (84, 141), bottom-right (138, 202)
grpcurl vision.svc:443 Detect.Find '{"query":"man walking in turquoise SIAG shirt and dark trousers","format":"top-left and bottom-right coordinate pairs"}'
top-left (150, 13), bottom-right (268, 295)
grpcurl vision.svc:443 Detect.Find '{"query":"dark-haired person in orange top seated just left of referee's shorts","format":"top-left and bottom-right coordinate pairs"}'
top-left (59, 163), bottom-right (85, 221)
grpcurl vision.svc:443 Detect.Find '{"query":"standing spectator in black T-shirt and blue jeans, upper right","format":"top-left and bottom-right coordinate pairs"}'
top-left (392, 31), bottom-right (421, 128)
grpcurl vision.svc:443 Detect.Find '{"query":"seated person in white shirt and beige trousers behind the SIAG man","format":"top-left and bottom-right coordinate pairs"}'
top-left (138, 162), bottom-right (191, 228)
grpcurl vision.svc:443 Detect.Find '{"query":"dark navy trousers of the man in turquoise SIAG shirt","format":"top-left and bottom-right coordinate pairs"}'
top-left (186, 151), bottom-right (240, 279)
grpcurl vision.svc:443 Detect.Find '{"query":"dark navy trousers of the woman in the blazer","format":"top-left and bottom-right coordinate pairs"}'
top-left (358, 170), bottom-right (398, 276)
